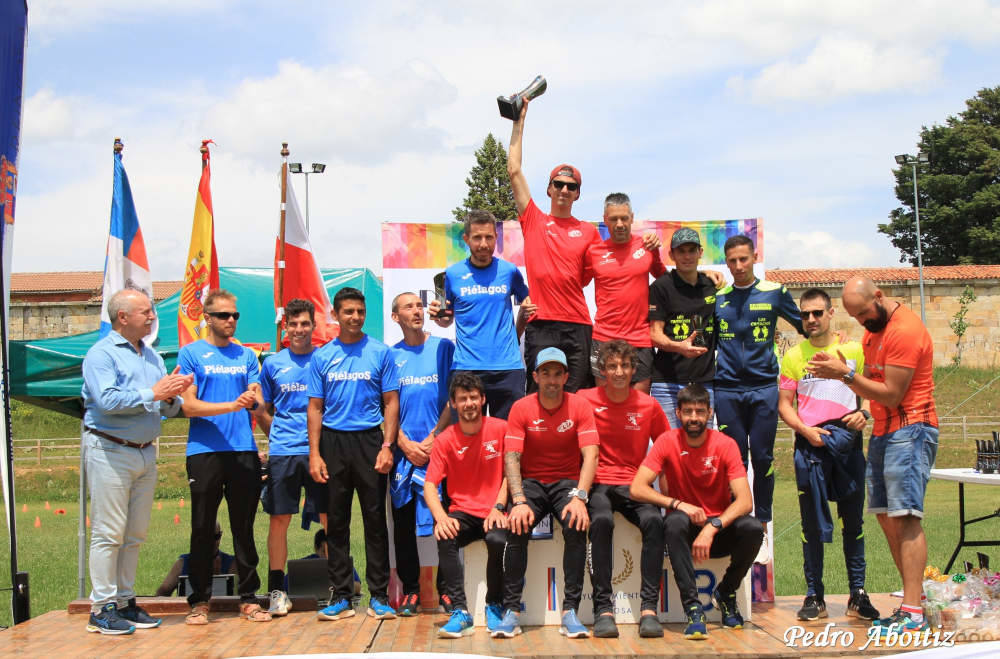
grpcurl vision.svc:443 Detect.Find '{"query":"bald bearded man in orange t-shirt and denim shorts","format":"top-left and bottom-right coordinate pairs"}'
top-left (806, 277), bottom-right (938, 636)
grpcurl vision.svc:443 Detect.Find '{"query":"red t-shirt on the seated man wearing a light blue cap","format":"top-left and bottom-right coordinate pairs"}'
top-left (504, 392), bottom-right (600, 482)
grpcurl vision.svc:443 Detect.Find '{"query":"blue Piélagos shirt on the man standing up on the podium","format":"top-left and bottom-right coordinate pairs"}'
top-left (444, 258), bottom-right (528, 371)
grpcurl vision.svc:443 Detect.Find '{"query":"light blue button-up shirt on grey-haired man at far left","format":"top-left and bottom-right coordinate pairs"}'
top-left (82, 330), bottom-right (182, 444)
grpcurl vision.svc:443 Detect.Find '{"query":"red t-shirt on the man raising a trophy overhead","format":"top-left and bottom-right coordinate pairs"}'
top-left (518, 200), bottom-right (601, 325)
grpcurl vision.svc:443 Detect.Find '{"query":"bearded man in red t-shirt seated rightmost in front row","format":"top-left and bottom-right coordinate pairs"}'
top-left (630, 384), bottom-right (764, 640)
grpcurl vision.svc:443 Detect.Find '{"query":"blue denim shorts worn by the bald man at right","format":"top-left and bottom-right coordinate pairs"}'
top-left (865, 423), bottom-right (938, 517)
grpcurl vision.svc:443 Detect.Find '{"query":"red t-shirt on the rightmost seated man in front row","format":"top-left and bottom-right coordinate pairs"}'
top-left (642, 428), bottom-right (747, 517)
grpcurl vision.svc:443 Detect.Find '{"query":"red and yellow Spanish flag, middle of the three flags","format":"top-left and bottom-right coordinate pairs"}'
top-left (177, 140), bottom-right (219, 347)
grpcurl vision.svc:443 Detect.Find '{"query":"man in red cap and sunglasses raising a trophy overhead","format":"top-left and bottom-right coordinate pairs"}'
top-left (507, 99), bottom-right (600, 392)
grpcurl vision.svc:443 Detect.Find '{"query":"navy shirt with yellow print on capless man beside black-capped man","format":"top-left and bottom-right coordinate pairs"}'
top-left (715, 279), bottom-right (803, 389)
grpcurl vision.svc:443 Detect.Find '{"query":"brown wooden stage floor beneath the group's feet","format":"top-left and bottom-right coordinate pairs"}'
top-left (0, 595), bottom-right (976, 659)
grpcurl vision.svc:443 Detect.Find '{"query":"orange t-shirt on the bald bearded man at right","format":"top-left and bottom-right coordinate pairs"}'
top-left (861, 305), bottom-right (938, 435)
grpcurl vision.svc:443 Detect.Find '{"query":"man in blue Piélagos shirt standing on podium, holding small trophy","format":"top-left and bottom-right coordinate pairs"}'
top-left (428, 210), bottom-right (528, 419)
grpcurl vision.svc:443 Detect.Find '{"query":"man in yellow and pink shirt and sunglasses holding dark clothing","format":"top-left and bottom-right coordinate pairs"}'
top-left (778, 288), bottom-right (879, 620)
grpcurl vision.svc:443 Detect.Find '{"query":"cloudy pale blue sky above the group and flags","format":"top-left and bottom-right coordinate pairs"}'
top-left (14, 0), bottom-right (1000, 279)
